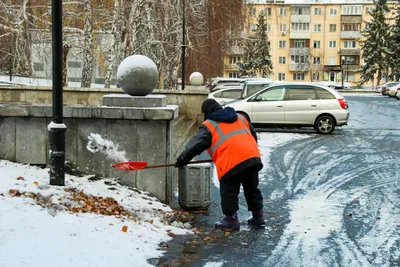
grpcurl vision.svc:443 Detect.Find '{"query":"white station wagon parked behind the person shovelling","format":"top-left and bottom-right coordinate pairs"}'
top-left (225, 83), bottom-right (349, 134)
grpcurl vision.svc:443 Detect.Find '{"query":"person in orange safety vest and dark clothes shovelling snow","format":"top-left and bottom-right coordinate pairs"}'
top-left (175, 99), bottom-right (265, 230)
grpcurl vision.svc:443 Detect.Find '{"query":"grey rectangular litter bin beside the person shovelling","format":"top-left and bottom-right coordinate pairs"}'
top-left (178, 163), bottom-right (212, 210)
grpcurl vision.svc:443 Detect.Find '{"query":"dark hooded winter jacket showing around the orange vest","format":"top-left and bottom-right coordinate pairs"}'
top-left (178, 107), bottom-right (263, 179)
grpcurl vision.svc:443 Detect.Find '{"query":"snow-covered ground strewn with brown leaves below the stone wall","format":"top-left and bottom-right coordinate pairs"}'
top-left (0, 160), bottom-right (192, 267)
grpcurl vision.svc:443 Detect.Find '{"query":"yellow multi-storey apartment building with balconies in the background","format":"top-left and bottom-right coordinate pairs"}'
top-left (224, 0), bottom-right (396, 85)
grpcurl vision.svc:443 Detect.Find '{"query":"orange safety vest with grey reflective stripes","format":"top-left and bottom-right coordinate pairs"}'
top-left (203, 114), bottom-right (261, 180)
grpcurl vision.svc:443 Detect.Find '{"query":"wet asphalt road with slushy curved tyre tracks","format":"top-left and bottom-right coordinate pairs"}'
top-left (150, 95), bottom-right (400, 267)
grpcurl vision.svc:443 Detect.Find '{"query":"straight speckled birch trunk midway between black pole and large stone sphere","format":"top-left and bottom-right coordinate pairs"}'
top-left (81, 0), bottom-right (93, 87)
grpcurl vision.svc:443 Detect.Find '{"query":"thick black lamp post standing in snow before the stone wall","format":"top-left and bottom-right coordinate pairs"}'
top-left (48, 0), bottom-right (67, 186)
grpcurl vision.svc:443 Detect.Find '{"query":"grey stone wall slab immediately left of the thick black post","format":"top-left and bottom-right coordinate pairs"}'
top-left (15, 117), bottom-right (48, 165)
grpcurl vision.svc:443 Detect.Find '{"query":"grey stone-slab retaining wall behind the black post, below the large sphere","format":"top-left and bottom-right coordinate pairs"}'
top-left (0, 103), bottom-right (178, 203)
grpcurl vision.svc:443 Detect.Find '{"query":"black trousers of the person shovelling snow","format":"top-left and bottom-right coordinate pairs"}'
top-left (220, 168), bottom-right (263, 215)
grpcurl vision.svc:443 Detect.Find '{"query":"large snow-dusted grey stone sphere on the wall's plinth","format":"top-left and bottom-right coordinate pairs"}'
top-left (117, 55), bottom-right (158, 96)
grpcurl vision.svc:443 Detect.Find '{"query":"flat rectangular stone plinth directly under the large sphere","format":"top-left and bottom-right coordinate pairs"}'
top-left (103, 94), bottom-right (167, 108)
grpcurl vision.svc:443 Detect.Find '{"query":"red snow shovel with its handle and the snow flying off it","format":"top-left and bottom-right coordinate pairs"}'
top-left (86, 133), bottom-right (212, 171)
